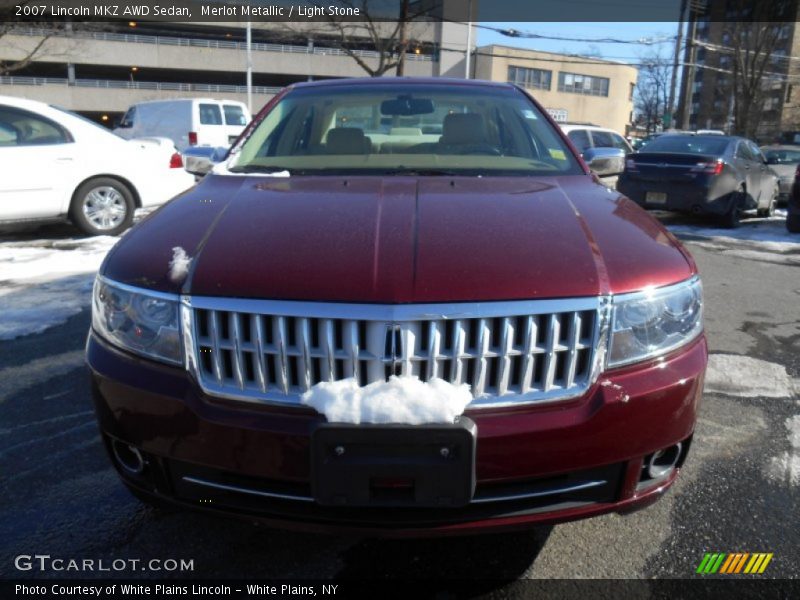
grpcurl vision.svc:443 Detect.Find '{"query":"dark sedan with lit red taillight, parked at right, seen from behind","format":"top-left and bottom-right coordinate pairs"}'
top-left (617, 135), bottom-right (778, 227)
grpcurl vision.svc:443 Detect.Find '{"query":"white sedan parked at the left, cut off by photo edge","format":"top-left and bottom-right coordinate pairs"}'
top-left (0, 96), bottom-right (194, 235)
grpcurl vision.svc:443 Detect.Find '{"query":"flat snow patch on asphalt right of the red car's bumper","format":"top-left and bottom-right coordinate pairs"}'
top-left (705, 354), bottom-right (798, 398)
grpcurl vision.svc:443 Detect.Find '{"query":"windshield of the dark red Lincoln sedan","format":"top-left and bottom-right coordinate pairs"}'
top-left (230, 83), bottom-right (583, 175)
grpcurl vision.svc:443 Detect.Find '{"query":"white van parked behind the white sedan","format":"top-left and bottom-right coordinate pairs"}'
top-left (114, 98), bottom-right (251, 152)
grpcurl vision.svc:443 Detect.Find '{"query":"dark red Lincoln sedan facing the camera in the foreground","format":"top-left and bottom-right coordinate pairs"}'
top-left (86, 77), bottom-right (707, 535)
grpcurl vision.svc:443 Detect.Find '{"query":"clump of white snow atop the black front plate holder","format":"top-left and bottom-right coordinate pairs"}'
top-left (302, 376), bottom-right (472, 425)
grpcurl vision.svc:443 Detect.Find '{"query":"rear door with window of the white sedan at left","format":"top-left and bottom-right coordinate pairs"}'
top-left (0, 104), bottom-right (75, 220)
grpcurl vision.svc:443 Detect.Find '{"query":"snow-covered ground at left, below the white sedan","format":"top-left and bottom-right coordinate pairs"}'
top-left (0, 236), bottom-right (118, 340)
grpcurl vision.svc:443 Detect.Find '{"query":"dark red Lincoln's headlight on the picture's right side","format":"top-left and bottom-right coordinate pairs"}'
top-left (608, 277), bottom-right (703, 367)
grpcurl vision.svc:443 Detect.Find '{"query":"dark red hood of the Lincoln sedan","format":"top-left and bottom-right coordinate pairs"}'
top-left (102, 175), bottom-right (695, 303)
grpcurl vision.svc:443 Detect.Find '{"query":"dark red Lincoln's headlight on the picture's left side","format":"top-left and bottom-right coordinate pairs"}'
top-left (92, 277), bottom-right (183, 364)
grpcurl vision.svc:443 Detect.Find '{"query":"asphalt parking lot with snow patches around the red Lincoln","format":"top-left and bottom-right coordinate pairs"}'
top-left (0, 211), bottom-right (800, 585)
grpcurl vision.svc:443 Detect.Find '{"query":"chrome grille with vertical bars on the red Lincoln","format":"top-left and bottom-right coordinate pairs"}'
top-left (183, 297), bottom-right (606, 407)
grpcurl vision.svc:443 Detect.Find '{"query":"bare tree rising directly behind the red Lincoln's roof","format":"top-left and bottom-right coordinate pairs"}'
top-left (283, 0), bottom-right (431, 77)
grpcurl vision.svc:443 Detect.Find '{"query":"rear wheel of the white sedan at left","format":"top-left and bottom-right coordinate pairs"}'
top-left (69, 177), bottom-right (136, 235)
